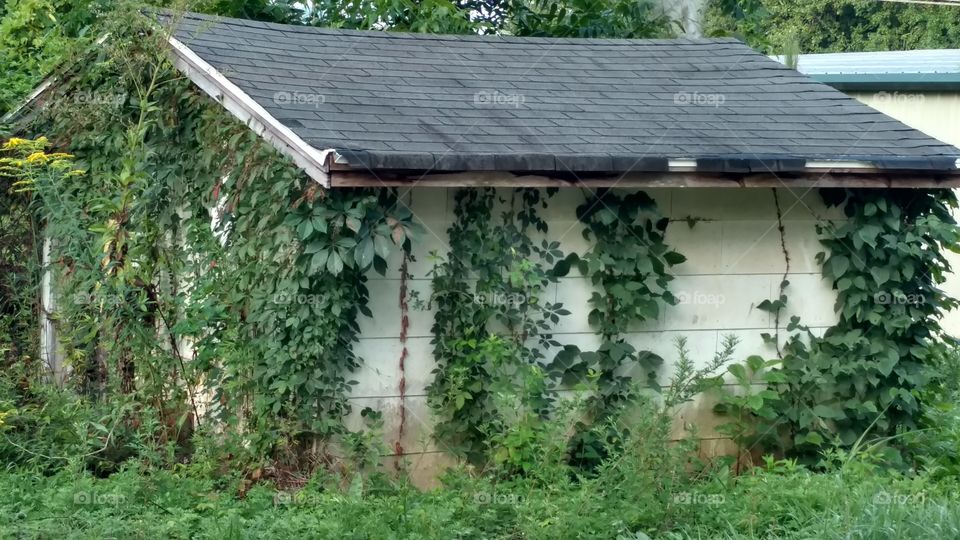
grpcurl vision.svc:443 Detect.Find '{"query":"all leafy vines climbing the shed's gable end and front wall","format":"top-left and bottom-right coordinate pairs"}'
top-left (7, 3), bottom-right (958, 480)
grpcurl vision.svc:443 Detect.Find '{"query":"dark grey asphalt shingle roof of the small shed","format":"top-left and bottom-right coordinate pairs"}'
top-left (175, 14), bottom-right (960, 172)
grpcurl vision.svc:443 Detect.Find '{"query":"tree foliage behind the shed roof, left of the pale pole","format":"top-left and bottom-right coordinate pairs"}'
top-left (0, 0), bottom-right (673, 117)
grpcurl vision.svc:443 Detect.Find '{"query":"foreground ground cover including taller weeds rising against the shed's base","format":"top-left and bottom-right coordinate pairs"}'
top-left (0, 360), bottom-right (960, 539)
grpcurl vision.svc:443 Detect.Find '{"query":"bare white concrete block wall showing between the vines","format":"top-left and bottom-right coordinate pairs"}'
top-left (349, 188), bottom-right (842, 486)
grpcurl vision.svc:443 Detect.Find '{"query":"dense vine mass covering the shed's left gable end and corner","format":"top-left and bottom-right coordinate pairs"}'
top-left (7, 14), bottom-right (417, 468)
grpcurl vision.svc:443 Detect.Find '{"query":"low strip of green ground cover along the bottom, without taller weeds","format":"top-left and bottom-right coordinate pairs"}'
top-left (0, 454), bottom-right (960, 539)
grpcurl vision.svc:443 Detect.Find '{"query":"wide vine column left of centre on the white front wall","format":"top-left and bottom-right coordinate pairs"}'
top-left (428, 188), bottom-right (569, 462)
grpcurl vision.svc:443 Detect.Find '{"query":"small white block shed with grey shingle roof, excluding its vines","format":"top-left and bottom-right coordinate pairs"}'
top-left (16, 14), bottom-right (960, 476)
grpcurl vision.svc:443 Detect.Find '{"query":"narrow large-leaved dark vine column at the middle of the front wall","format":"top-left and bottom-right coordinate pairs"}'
top-left (551, 190), bottom-right (686, 464)
